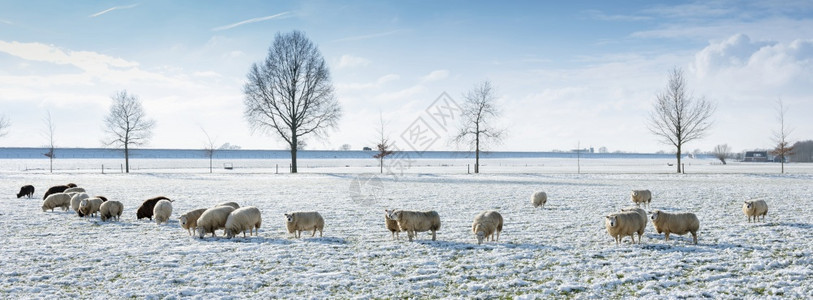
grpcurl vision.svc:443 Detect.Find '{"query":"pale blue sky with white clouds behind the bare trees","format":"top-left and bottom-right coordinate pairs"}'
top-left (0, 0), bottom-right (813, 152)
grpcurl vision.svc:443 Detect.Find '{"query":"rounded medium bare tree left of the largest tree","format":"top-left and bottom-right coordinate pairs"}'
top-left (102, 90), bottom-right (155, 173)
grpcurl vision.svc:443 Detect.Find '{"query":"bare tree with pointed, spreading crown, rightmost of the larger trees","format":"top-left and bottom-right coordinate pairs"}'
top-left (648, 67), bottom-right (717, 173)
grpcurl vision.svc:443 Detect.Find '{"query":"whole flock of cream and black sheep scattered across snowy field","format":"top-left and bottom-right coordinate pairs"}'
top-left (17, 183), bottom-right (768, 245)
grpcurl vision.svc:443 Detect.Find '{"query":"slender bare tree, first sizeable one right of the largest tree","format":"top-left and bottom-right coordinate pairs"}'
top-left (453, 81), bottom-right (505, 173)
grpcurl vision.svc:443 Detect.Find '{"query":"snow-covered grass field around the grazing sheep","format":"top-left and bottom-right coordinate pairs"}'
top-left (0, 160), bottom-right (813, 299)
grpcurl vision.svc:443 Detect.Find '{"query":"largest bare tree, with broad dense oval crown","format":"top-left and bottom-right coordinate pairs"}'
top-left (243, 31), bottom-right (342, 173)
